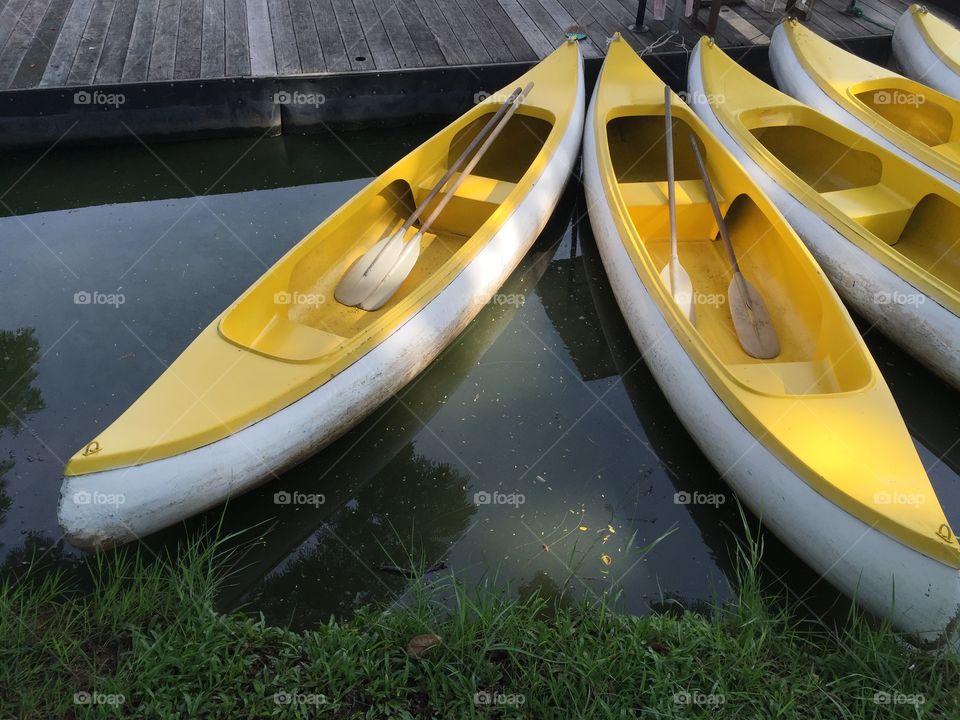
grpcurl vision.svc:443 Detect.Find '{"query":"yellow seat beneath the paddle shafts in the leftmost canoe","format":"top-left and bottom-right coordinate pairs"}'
top-left (415, 170), bottom-right (517, 237)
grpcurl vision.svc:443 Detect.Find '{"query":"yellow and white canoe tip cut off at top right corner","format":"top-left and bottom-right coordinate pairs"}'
top-left (893, 3), bottom-right (960, 100)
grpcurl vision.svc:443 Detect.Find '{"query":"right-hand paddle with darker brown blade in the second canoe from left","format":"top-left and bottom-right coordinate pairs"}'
top-left (690, 135), bottom-right (780, 360)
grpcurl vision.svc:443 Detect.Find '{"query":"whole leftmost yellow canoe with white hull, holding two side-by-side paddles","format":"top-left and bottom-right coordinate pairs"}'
top-left (59, 41), bottom-right (585, 547)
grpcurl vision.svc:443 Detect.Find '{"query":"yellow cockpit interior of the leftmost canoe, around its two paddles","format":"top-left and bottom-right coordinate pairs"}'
top-left (220, 107), bottom-right (553, 362)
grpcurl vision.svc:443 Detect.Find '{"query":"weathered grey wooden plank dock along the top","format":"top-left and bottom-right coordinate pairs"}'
top-left (0, 0), bottom-right (957, 90)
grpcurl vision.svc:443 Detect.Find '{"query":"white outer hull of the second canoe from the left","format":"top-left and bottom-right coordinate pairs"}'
top-left (583, 59), bottom-right (960, 648)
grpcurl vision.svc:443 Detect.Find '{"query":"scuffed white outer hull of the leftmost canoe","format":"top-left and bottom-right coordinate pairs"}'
top-left (58, 62), bottom-right (585, 548)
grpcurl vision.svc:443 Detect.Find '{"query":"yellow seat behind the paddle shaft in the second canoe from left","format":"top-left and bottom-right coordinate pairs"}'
top-left (619, 180), bottom-right (729, 243)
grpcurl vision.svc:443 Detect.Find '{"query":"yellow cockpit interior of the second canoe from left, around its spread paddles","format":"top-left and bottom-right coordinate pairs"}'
top-left (607, 107), bottom-right (872, 395)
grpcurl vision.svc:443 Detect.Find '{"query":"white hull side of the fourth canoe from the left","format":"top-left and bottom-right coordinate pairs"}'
top-left (770, 23), bottom-right (960, 191)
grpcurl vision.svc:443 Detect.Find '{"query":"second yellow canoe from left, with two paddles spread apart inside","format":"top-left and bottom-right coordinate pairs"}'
top-left (583, 39), bottom-right (960, 642)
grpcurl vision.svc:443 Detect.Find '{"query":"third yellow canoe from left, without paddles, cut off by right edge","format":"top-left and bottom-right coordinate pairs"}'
top-left (689, 41), bottom-right (960, 394)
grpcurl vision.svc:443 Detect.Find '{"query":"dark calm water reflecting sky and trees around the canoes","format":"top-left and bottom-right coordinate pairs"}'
top-left (0, 126), bottom-right (960, 627)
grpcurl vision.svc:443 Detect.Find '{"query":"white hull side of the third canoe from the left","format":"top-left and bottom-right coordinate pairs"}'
top-left (688, 47), bottom-right (960, 388)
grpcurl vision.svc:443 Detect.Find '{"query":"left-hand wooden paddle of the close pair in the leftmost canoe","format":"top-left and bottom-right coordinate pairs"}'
top-left (334, 88), bottom-right (521, 305)
